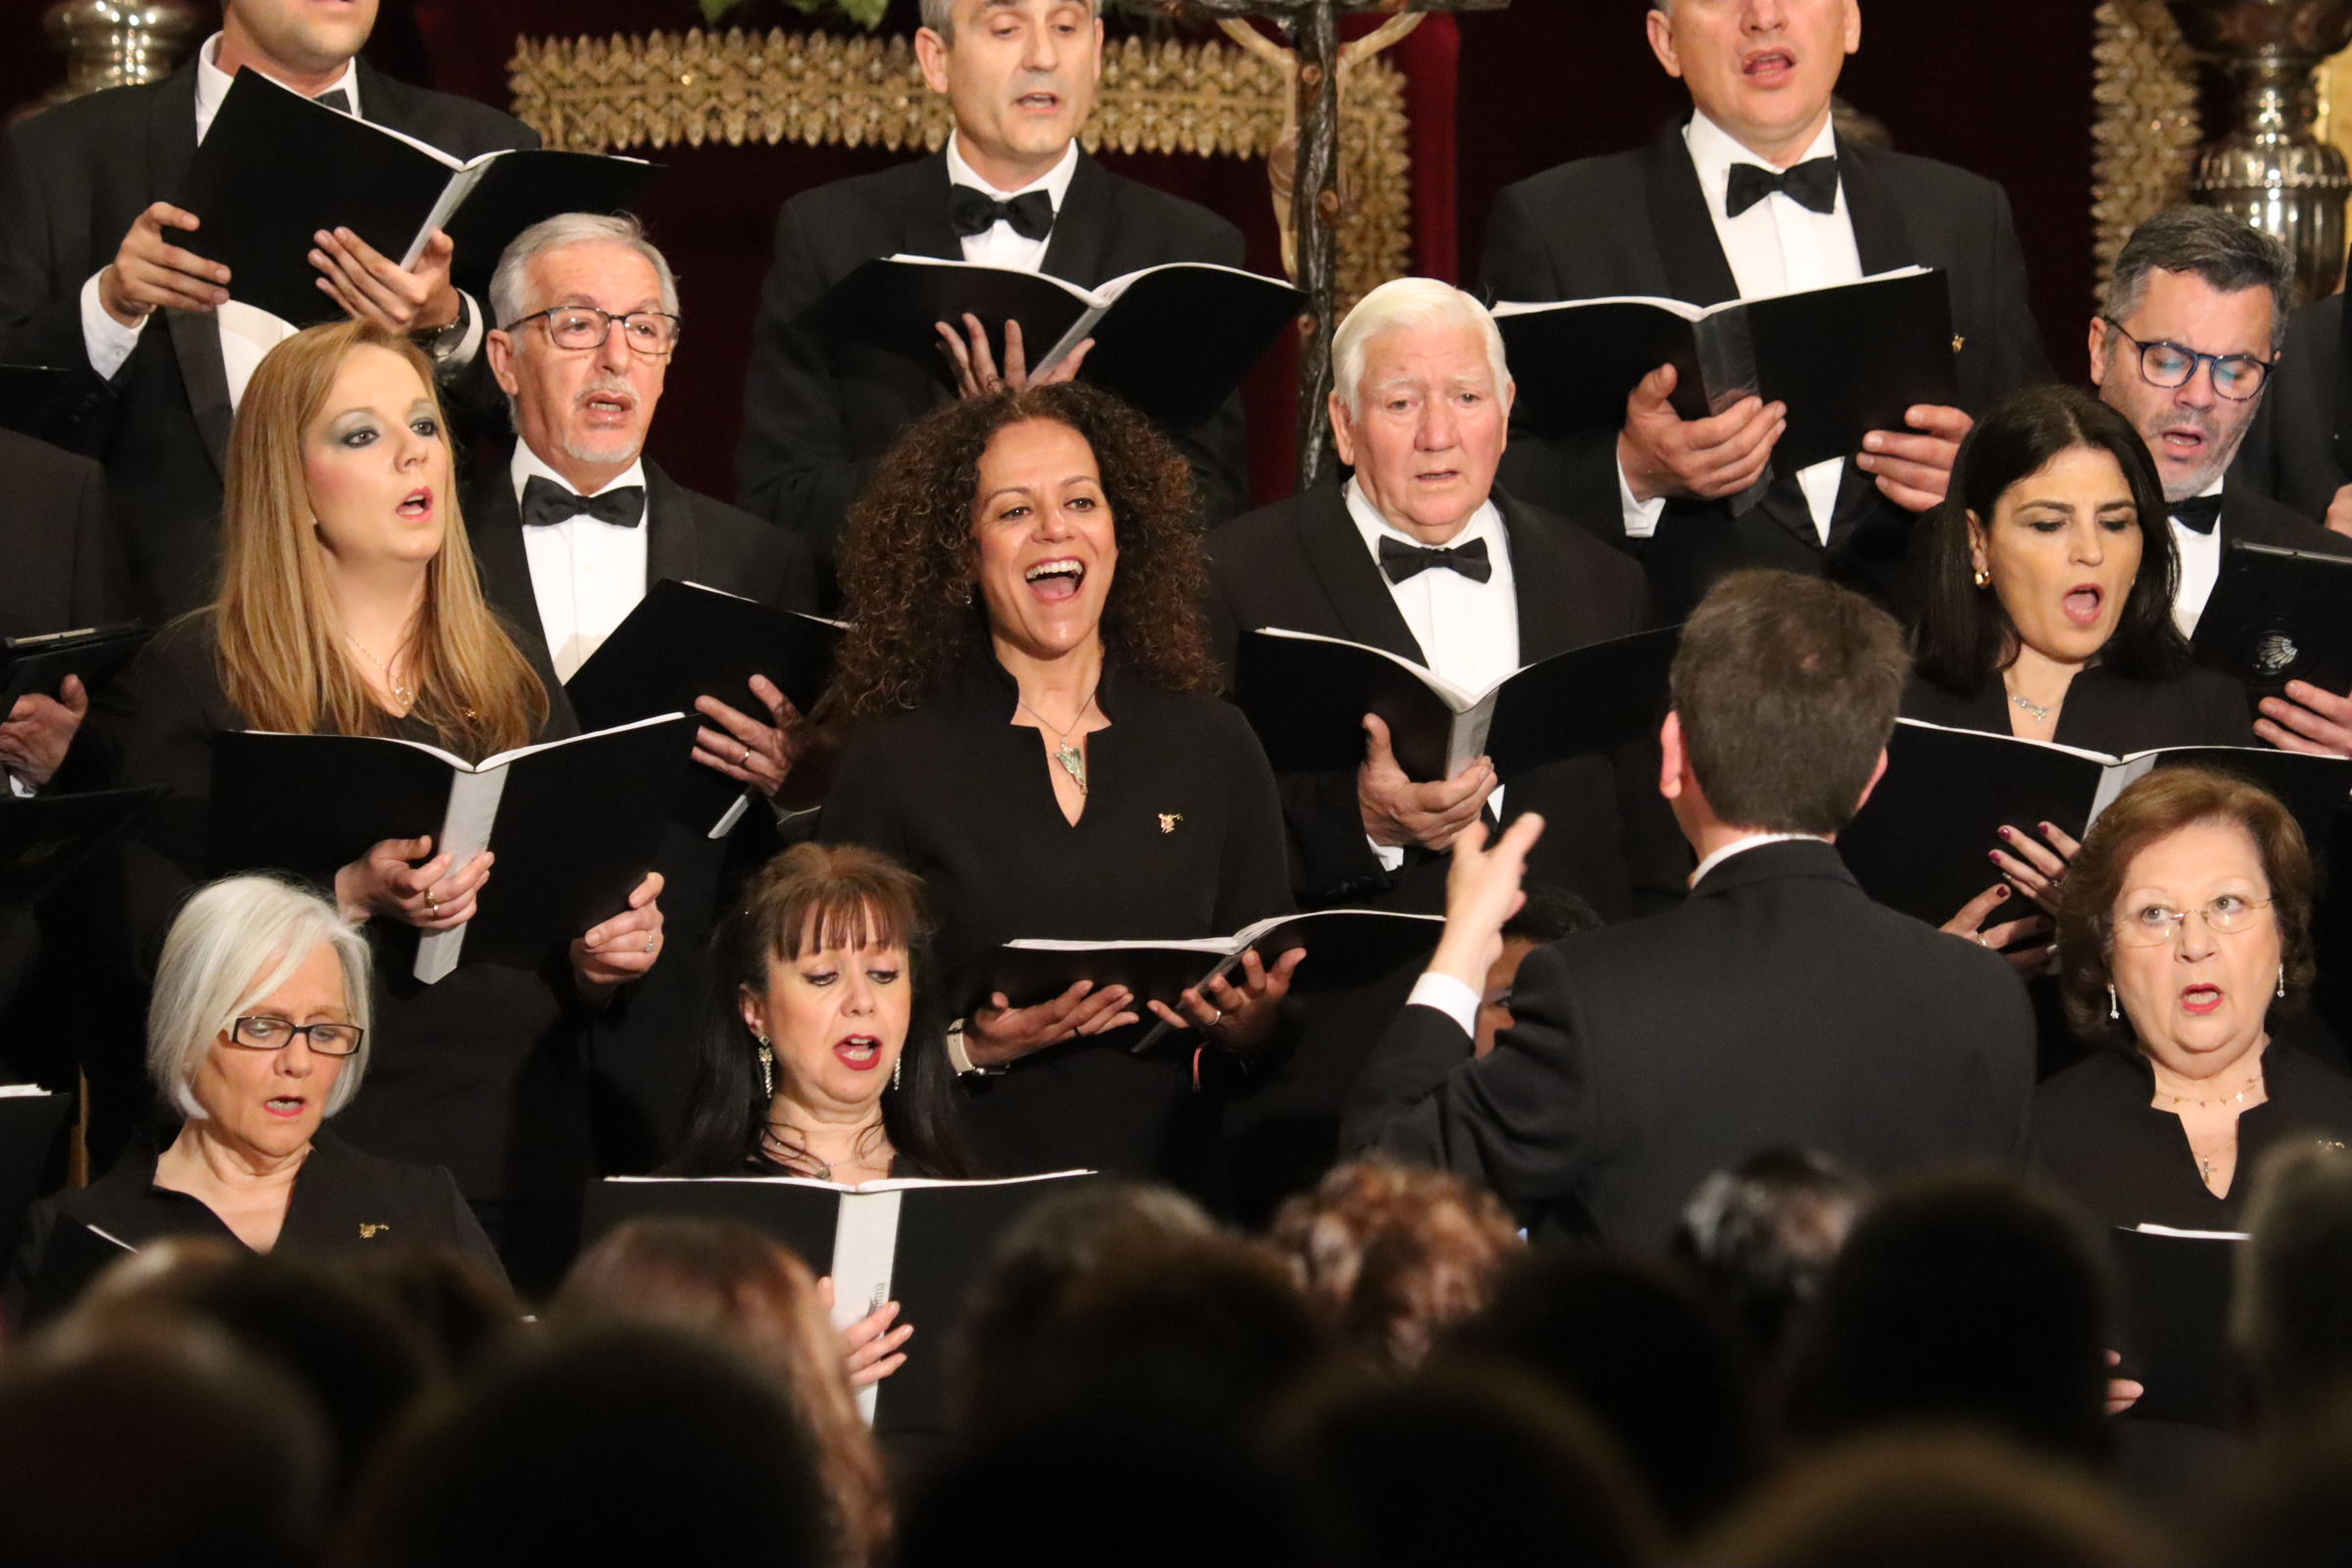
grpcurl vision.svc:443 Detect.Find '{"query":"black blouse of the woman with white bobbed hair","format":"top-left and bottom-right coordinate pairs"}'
top-left (7, 1126), bottom-right (506, 1326)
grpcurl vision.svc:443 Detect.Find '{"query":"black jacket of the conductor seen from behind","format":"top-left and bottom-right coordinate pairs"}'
top-left (1343, 842), bottom-right (2034, 1249)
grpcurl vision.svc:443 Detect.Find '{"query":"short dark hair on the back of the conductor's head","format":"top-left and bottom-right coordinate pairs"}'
top-left (1668, 569), bottom-right (1910, 835)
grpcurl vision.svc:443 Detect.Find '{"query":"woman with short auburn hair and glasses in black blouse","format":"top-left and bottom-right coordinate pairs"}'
top-left (2033, 766), bottom-right (2352, 1230)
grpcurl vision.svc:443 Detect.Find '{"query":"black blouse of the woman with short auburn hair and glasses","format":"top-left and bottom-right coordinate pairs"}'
top-left (2033, 1039), bottom-right (2352, 1230)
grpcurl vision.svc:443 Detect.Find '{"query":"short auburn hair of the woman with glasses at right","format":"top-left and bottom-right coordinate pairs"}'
top-left (2058, 766), bottom-right (2319, 1046)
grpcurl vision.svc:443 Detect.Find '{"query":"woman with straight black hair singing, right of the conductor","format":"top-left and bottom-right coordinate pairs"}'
top-left (1903, 385), bottom-right (2256, 971)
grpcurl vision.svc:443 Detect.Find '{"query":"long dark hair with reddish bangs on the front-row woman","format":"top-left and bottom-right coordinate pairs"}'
top-left (665, 844), bottom-right (974, 1178)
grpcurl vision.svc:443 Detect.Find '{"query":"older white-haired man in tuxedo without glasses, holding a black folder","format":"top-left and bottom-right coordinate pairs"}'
top-left (1206, 277), bottom-right (1691, 1215)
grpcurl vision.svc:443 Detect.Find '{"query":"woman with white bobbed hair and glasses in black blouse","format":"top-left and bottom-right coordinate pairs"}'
top-left (7, 877), bottom-right (499, 1326)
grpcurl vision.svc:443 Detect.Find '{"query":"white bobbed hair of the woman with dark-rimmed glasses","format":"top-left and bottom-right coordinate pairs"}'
top-left (148, 877), bottom-right (369, 1121)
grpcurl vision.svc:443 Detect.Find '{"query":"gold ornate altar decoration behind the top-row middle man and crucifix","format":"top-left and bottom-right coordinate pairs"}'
top-left (506, 28), bottom-right (1413, 308)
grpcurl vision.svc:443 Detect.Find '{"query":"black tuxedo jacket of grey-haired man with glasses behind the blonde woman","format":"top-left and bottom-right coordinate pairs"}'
top-left (466, 459), bottom-right (816, 1171)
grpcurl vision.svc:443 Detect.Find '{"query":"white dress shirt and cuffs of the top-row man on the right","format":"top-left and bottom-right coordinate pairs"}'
top-left (1618, 113), bottom-right (1863, 543)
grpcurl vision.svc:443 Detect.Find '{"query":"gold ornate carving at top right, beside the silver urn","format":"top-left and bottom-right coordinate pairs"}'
top-left (2091, 0), bottom-right (2199, 291)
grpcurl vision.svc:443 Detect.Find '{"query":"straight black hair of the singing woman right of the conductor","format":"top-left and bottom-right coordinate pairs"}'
top-left (1912, 385), bottom-right (2189, 696)
